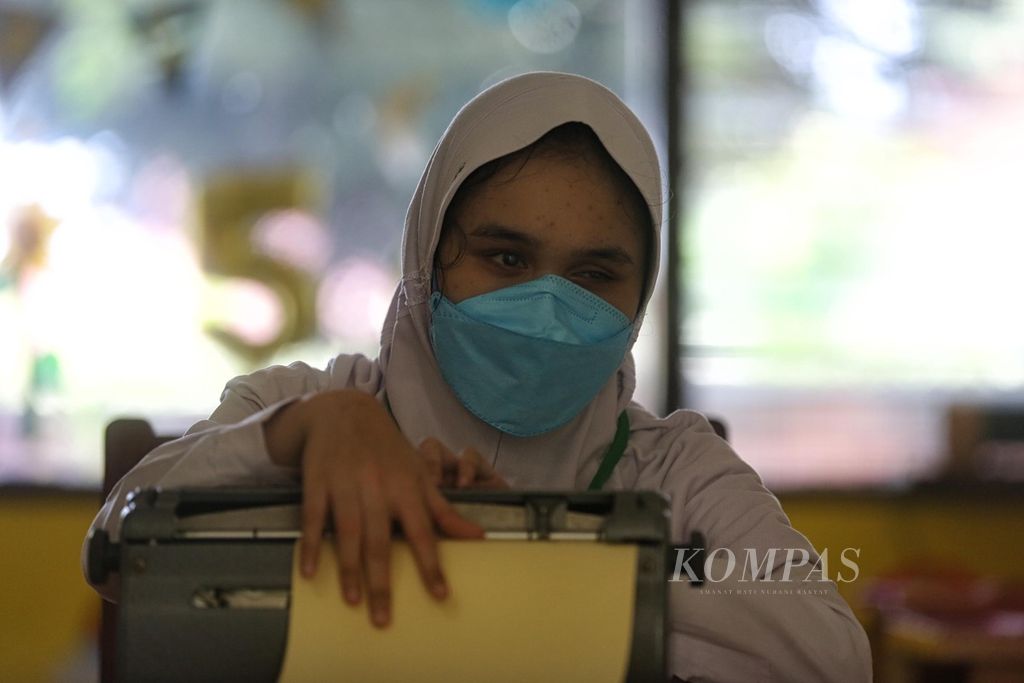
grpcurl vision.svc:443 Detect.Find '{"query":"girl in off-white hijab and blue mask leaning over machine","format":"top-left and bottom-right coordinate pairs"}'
top-left (86, 73), bottom-right (870, 681)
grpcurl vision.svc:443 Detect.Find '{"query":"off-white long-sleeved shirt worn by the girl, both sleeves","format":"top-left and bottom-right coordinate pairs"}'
top-left (83, 361), bottom-right (871, 683)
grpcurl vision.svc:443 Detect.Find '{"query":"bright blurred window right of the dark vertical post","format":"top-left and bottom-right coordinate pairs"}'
top-left (678, 0), bottom-right (1024, 486)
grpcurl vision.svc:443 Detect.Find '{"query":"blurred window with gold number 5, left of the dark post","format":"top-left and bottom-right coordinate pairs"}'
top-left (0, 0), bottom-right (663, 486)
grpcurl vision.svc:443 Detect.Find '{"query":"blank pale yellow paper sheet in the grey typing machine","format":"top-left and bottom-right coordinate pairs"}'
top-left (279, 541), bottom-right (637, 683)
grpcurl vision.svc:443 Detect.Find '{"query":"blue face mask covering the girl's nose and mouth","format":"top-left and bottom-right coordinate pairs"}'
top-left (430, 275), bottom-right (633, 436)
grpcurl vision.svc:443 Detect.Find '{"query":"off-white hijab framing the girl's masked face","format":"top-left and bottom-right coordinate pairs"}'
top-left (368, 73), bottom-right (662, 488)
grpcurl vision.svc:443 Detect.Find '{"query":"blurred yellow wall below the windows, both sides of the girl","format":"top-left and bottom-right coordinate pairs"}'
top-left (0, 492), bottom-right (1024, 681)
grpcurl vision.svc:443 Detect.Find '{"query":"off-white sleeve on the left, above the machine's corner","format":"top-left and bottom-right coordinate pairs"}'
top-left (82, 362), bottom-right (330, 599)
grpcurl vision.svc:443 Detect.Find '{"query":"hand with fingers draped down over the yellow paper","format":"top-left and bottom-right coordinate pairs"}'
top-left (264, 390), bottom-right (483, 627)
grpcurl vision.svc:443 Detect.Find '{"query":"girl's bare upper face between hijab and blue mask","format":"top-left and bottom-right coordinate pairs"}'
top-left (438, 154), bottom-right (647, 321)
